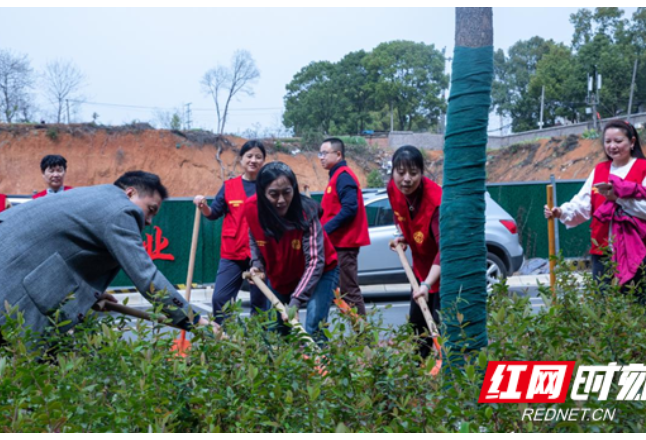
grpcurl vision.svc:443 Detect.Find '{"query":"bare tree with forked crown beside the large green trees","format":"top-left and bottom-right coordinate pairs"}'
top-left (202, 50), bottom-right (260, 134)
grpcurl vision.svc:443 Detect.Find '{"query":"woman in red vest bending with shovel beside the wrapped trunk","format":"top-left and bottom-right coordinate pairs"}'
top-left (388, 145), bottom-right (442, 358)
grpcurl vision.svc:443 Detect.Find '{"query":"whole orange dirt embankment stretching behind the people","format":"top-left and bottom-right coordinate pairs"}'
top-left (0, 124), bottom-right (605, 197)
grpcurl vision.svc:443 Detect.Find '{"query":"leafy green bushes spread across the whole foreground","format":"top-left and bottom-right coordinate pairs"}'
top-left (0, 258), bottom-right (646, 433)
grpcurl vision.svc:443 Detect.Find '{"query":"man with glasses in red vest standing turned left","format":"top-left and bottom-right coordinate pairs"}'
top-left (319, 138), bottom-right (370, 316)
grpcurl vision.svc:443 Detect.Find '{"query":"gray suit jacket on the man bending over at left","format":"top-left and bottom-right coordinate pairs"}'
top-left (0, 185), bottom-right (197, 332)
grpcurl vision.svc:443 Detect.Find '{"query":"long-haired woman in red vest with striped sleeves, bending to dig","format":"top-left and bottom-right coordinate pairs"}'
top-left (245, 162), bottom-right (339, 342)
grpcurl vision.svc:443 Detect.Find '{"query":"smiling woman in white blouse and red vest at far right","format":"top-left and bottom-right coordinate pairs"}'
top-left (545, 121), bottom-right (646, 292)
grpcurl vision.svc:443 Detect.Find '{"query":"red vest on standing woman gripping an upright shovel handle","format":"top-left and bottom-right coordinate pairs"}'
top-left (220, 176), bottom-right (251, 261)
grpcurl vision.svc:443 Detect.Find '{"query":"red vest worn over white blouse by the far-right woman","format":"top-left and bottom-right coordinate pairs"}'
top-left (590, 159), bottom-right (646, 255)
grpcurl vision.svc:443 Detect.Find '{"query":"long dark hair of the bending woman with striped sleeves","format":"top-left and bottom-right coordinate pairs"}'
top-left (256, 162), bottom-right (316, 240)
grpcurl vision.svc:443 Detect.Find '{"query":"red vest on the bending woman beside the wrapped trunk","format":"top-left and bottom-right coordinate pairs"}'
top-left (388, 177), bottom-right (442, 293)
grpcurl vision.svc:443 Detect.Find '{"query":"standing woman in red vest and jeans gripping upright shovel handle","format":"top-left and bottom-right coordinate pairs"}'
top-left (193, 140), bottom-right (270, 324)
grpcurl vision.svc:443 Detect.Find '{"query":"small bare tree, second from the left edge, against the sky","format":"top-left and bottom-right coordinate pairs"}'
top-left (43, 60), bottom-right (85, 124)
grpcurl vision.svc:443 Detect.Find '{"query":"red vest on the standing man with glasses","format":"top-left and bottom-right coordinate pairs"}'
top-left (321, 167), bottom-right (370, 249)
